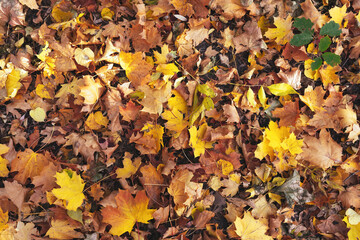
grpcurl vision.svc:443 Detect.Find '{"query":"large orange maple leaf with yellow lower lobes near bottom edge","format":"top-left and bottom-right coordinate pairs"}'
top-left (101, 190), bottom-right (156, 236)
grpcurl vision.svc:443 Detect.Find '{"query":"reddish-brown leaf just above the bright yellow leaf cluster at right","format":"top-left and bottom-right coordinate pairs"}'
top-left (272, 99), bottom-right (300, 127)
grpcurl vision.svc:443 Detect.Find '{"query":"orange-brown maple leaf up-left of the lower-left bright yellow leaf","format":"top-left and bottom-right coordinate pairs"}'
top-left (11, 148), bottom-right (51, 184)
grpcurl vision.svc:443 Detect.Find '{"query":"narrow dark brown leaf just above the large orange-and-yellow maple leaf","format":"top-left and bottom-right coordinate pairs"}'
top-left (140, 164), bottom-right (165, 205)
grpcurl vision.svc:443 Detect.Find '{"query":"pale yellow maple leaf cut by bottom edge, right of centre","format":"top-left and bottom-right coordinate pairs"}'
top-left (234, 211), bottom-right (273, 240)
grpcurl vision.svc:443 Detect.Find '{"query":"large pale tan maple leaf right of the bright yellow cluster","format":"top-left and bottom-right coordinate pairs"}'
top-left (300, 129), bottom-right (342, 170)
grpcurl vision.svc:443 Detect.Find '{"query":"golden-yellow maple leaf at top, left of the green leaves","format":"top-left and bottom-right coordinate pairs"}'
top-left (265, 15), bottom-right (293, 45)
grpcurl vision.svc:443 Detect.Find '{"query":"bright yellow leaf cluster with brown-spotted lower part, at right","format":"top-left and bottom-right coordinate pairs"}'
top-left (255, 121), bottom-right (303, 172)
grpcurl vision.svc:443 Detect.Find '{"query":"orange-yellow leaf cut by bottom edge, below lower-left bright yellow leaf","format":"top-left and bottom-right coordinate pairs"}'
top-left (46, 220), bottom-right (84, 239)
